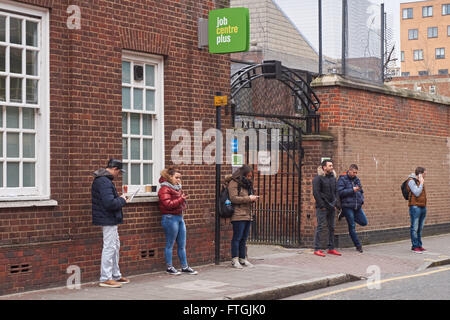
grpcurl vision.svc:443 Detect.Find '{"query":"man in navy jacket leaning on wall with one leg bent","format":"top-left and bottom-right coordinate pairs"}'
top-left (337, 164), bottom-right (367, 252)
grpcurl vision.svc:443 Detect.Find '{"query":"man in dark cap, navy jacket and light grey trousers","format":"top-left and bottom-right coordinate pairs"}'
top-left (91, 159), bottom-right (130, 288)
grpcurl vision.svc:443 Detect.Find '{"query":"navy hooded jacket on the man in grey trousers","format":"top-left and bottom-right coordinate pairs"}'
top-left (91, 168), bottom-right (127, 226)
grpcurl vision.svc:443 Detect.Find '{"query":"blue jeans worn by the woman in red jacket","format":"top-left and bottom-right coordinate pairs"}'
top-left (161, 214), bottom-right (188, 268)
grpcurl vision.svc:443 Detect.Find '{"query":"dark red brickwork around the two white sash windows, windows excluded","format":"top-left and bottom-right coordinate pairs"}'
top-left (0, 0), bottom-right (230, 294)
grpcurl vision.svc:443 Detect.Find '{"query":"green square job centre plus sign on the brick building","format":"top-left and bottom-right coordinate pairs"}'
top-left (208, 8), bottom-right (250, 53)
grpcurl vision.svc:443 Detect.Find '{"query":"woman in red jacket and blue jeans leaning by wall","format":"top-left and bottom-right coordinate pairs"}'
top-left (158, 167), bottom-right (197, 275)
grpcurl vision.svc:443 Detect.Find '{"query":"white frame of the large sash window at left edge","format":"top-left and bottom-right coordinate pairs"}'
top-left (0, 1), bottom-right (50, 201)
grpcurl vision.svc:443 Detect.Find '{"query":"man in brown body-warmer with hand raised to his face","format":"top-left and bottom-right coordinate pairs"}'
top-left (407, 167), bottom-right (427, 253)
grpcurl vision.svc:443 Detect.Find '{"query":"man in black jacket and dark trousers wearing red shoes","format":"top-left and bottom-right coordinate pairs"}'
top-left (313, 160), bottom-right (341, 257)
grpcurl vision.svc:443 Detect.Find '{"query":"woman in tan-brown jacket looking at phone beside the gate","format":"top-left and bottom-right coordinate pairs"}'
top-left (225, 165), bottom-right (258, 269)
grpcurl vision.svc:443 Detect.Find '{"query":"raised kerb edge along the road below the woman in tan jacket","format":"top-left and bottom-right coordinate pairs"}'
top-left (223, 273), bottom-right (361, 300)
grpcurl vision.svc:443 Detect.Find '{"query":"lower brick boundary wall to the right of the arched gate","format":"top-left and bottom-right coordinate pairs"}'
top-left (312, 78), bottom-right (450, 248)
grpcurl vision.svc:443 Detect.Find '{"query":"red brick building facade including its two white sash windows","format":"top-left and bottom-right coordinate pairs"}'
top-left (0, 0), bottom-right (230, 294)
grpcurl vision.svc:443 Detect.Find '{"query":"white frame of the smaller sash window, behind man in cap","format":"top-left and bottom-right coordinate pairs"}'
top-left (121, 50), bottom-right (165, 197)
